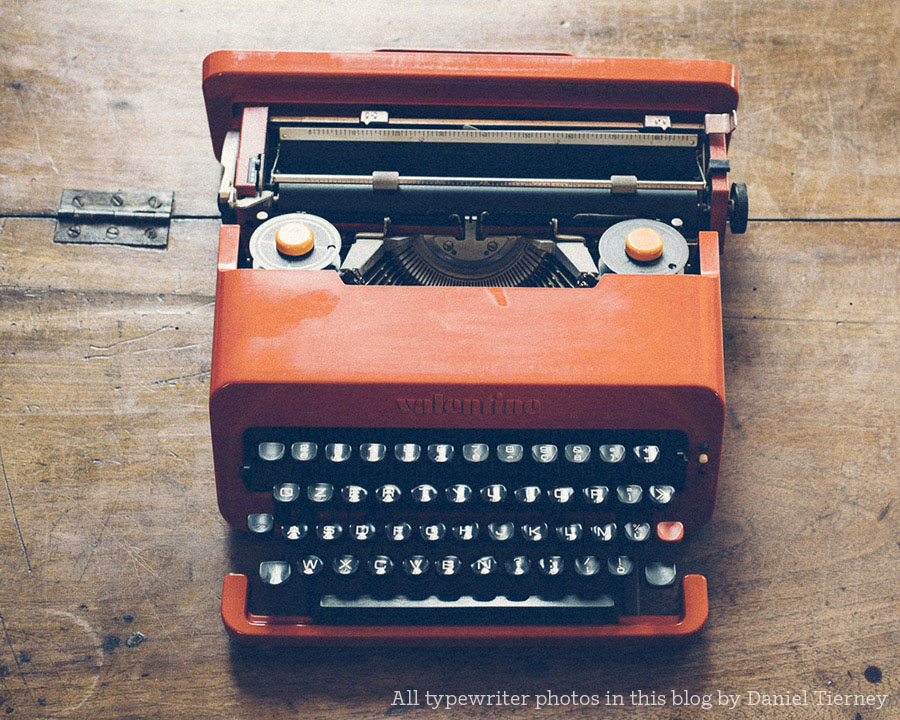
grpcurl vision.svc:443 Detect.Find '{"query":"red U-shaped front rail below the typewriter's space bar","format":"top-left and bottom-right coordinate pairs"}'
top-left (222, 573), bottom-right (709, 646)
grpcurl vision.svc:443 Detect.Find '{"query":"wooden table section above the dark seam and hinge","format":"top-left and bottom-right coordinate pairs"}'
top-left (0, 0), bottom-right (900, 218)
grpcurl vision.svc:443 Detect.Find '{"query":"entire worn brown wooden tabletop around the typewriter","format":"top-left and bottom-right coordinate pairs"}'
top-left (0, 0), bottom-right (900, 720)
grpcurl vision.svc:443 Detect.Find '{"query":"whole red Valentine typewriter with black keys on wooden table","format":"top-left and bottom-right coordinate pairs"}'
top-left (204, 51), bottom-right (746, 645)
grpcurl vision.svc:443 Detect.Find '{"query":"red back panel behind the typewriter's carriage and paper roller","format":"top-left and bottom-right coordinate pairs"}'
top-left (203, 50), bottom-right (738, 157)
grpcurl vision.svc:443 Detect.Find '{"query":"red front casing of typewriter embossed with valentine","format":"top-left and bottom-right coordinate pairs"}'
top-left (210, 225), bottom-right (724, 530)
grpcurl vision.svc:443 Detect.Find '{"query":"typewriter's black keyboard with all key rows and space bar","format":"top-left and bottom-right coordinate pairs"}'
top-left (242, 428), bottom-right (687, 624)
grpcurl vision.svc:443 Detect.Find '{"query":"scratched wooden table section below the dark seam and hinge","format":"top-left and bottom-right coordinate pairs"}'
top-left (0, 218), bottom-right (900, 720)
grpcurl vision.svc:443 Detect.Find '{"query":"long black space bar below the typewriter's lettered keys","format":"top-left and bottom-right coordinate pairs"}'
top-left (317, 595), bottom-right (619, 625)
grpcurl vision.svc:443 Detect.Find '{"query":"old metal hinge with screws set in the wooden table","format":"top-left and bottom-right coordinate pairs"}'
top-left (53, 190), bottom-right (174, 248)
